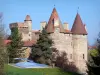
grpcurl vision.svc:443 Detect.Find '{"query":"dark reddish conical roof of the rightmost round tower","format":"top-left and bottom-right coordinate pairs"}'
top-left (71, 13), bottom-right (87, 35)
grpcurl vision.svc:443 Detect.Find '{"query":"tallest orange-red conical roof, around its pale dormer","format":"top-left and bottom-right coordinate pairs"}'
top-left (46, 8), bottom-right (65, 33)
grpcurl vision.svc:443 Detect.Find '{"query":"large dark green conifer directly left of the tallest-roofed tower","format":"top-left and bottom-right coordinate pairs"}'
top-left (31, 29), bottom-right (53, 64)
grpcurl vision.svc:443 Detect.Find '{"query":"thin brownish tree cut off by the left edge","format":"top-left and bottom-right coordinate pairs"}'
top-left (0, 13), bottom-right (7, 75)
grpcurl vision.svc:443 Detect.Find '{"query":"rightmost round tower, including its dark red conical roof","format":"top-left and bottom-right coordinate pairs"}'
top-left (71, 13), bottom-right (87, 73)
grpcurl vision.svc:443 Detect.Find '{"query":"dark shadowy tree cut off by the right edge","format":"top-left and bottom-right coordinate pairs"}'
top-left (87, 33), bottom-right (100, 75)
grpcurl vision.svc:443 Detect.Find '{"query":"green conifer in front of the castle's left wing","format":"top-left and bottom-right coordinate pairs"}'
top-left (7, 27), bottom-right (24, 62)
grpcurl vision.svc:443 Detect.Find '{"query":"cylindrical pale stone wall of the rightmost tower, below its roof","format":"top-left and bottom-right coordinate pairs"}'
top-left (72, 35), bottom-right (87, 72)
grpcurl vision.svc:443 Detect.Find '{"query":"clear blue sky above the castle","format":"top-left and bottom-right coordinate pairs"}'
top-left (0, 0), bottom-right (100, 45)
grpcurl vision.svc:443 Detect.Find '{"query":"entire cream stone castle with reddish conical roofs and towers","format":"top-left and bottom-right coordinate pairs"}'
top-left (10, 8), bottom-right (87, 72)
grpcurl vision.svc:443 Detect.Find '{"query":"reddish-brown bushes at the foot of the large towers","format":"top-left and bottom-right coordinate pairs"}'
top-left (52, 48), bottom-right (78, 72)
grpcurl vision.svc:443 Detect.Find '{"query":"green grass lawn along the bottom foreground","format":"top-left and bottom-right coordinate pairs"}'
top-left (5, 65), bottom-right (81, 75)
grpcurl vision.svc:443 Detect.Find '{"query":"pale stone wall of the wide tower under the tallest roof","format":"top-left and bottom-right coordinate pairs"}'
top-left (50, 32), bottom-right (73, 62)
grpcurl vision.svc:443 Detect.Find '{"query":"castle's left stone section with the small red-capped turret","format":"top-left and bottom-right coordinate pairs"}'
top-left (10, 15), bottom-right (39, 41)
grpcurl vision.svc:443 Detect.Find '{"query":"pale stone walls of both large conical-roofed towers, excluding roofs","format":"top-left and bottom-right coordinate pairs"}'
top-left (50, 32), bottom-right (87, 72)
